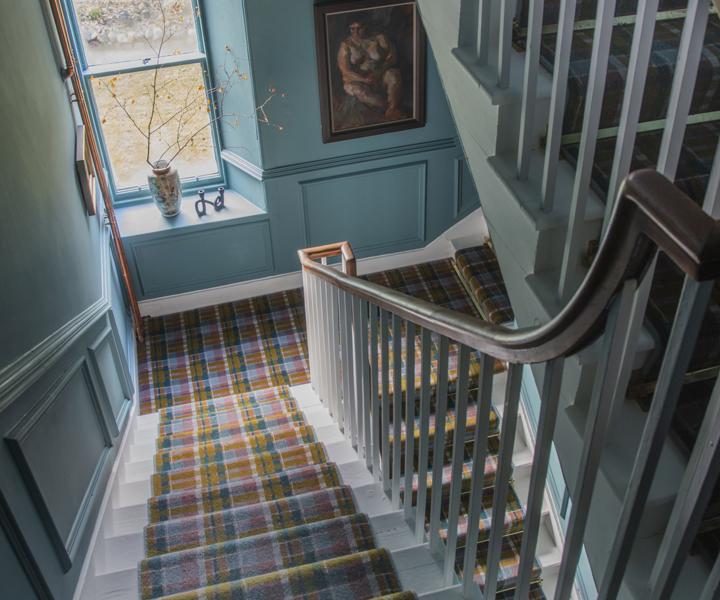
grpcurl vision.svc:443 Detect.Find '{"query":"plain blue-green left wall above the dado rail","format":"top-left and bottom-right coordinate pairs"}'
top-left (0, 2), bottom-right (102, 369)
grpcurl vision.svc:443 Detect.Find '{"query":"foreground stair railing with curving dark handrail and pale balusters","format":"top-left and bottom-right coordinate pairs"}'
top-left (298, 170), bottom-right (720, 600)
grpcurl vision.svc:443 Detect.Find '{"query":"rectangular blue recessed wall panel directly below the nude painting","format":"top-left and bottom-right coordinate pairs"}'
top-left (300, 162), bottom-right (426, 256)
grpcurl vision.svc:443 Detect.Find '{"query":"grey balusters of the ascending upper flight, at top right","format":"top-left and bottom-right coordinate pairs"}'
top-left (458, 0), bottom-right (720, 304)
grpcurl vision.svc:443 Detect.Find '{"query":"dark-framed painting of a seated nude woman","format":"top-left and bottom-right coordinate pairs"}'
top-left (315, 0), bottom-right (425, 143)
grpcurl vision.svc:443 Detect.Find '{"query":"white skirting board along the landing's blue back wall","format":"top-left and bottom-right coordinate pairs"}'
top-left (138, 208), bottom-right (488, 317)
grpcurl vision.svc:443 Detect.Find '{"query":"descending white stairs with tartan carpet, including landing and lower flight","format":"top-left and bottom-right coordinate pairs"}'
top-left (80, 260), bottom-right (561, 600)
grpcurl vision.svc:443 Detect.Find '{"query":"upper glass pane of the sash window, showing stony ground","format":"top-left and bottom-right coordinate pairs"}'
top-left (73, 0), bottom-right (198, 65)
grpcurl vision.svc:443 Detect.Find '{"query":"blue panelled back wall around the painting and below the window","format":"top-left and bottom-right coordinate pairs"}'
top-left (119, 0), bottom-right (478, 300)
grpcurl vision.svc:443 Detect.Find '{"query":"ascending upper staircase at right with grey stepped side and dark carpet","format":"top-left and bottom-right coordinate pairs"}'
top-left (418, 0), bottom-right (720, 599)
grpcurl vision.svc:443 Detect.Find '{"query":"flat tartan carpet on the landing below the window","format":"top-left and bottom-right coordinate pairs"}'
top-left (138, 290), bottom-right (309, 414)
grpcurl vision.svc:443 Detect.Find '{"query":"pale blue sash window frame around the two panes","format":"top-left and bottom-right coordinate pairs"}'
top-left (62, 0), bottom-right (227, 206)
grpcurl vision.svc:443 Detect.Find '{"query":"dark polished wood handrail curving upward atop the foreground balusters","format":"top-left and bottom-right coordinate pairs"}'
top-left (298, 169), bottom-right (720, 363)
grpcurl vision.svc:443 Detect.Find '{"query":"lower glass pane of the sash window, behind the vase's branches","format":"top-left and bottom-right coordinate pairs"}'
top-left (90, 63), bottom-right (218, 189)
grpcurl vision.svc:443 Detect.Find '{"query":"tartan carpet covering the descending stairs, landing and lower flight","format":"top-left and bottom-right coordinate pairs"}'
top-left (138, 268), bottom-right (544, 600)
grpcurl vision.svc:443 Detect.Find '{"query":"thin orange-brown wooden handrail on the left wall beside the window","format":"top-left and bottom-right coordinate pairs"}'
top-left (50, 0), bottom-right (145, 344)
